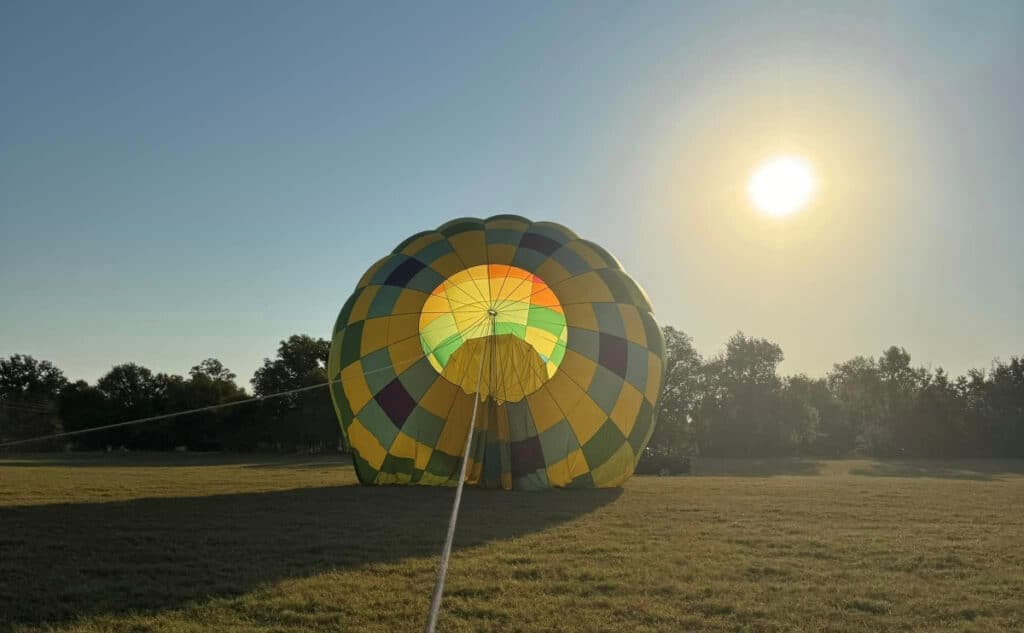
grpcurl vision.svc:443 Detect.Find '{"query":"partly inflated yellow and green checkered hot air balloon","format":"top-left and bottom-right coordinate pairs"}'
top-left (328, 215), bottom-right (665, 490)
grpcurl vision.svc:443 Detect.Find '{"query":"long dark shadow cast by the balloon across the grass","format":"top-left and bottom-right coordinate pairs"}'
top-left (0, 486), bottom-right (622, 631)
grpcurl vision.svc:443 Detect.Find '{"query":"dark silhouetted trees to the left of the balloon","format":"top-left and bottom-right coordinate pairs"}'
top-left (0, 335), bottom-right (340, 451)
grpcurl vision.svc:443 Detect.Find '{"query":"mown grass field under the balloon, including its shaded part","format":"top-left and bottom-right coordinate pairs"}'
top-left (0, 455), bottom-right (1024, 632)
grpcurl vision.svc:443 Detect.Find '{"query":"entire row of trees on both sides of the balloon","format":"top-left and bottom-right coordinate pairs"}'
top-left (0, 326), bottom-right (1024, 459)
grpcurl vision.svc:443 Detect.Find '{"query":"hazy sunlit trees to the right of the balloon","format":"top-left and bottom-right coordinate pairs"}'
top-left (648, 326), bottom-right (1024, 458)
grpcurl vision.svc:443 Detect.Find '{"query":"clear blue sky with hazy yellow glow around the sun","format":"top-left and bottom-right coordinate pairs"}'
top-left (0, 1), bottom-right (1024, 383)
